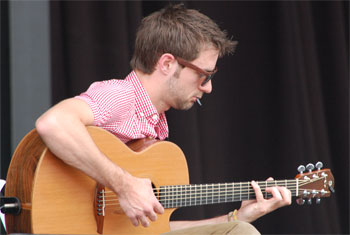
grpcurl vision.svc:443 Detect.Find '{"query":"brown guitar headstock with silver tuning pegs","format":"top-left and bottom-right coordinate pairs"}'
top-left (295, 162), bottom-right (335, 205)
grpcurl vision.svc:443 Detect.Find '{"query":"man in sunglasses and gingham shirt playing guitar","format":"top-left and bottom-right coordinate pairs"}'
top-left (36, 5), bottom-right (291, 234)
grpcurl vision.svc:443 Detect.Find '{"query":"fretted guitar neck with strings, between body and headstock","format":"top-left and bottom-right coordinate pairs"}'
top-left (159, 179), bottom-right (298, 208)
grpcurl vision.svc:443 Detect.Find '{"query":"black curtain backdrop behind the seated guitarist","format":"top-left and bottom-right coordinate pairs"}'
top-left (1, 1), bottom-right (349, 234)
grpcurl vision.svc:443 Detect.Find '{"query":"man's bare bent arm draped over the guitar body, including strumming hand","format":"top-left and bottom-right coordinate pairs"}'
top-left (36, 98), bottom-right (164, 226)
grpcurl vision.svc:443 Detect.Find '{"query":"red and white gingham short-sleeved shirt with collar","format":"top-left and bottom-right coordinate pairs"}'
top-left (76, 71), bottom-right (169, 143)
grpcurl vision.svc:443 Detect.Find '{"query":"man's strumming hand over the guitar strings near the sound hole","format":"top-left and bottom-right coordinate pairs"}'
top-left (117, 173), bottom-right (164, 227)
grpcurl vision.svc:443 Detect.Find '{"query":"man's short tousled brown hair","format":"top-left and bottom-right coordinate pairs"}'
top-left (130, 4), bottom-right (237, 74)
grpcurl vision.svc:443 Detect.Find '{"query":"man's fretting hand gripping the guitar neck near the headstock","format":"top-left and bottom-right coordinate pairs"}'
top-left (237, 178), bottom-right (292, 222)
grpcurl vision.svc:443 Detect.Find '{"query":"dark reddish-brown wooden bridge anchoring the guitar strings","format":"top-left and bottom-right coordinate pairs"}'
top-left (94, 184), bottom-right (106, 234)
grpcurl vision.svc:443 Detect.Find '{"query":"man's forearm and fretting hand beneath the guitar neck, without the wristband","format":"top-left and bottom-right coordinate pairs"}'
top-left (170, 178), bottom-right (291, 230)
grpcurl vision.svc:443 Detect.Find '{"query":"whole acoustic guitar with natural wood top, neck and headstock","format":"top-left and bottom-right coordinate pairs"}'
top-left (5, 127), bottom-right (334, 234)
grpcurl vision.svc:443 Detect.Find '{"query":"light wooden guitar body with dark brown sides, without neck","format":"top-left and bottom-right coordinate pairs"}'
top-left (5, 127), bottom-right (189, 234)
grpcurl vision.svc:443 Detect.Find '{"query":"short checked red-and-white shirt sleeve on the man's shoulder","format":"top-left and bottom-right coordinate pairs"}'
top-left (75, 79), bottom-right (135, 127)
